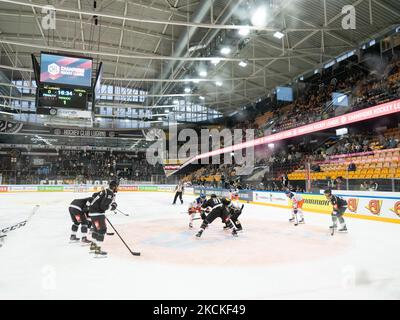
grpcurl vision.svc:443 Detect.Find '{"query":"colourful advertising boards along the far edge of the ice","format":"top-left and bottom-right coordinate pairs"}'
top-left (0, 184), bottom-right (400, 224)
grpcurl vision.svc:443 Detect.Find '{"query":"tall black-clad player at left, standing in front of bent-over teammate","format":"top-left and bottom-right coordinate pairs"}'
top-left (89, 181), bottom-right (118, 256)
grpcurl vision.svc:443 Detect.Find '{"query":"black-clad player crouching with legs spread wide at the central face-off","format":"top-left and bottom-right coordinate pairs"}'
top-left (196, 195), bottom-right (237, 238)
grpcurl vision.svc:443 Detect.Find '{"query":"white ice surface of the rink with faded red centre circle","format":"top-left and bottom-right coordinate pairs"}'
top-left (0, 192), bottom-right (400, 300)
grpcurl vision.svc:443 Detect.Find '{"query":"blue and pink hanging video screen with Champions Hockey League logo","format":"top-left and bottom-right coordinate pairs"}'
top-left (40, 53), bottom-right (93, 88)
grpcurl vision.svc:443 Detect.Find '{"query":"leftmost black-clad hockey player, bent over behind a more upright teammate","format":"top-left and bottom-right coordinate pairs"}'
top-left (69, 197), bottom-right (93, 243)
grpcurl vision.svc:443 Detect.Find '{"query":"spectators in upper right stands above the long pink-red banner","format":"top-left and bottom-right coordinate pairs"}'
top-left (253, 57), bottom-right (400, 133)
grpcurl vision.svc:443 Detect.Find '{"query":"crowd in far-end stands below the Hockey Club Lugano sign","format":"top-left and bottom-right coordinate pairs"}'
top-left (0, 150), bottom-right (164, 184)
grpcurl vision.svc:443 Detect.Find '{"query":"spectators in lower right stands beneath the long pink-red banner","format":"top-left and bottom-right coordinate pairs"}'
top-left (185, 128), bottom-right (400, 192)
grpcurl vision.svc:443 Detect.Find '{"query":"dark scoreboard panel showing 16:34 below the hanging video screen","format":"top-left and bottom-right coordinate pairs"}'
top-left (38, 87), bottom-right (87, 110)
